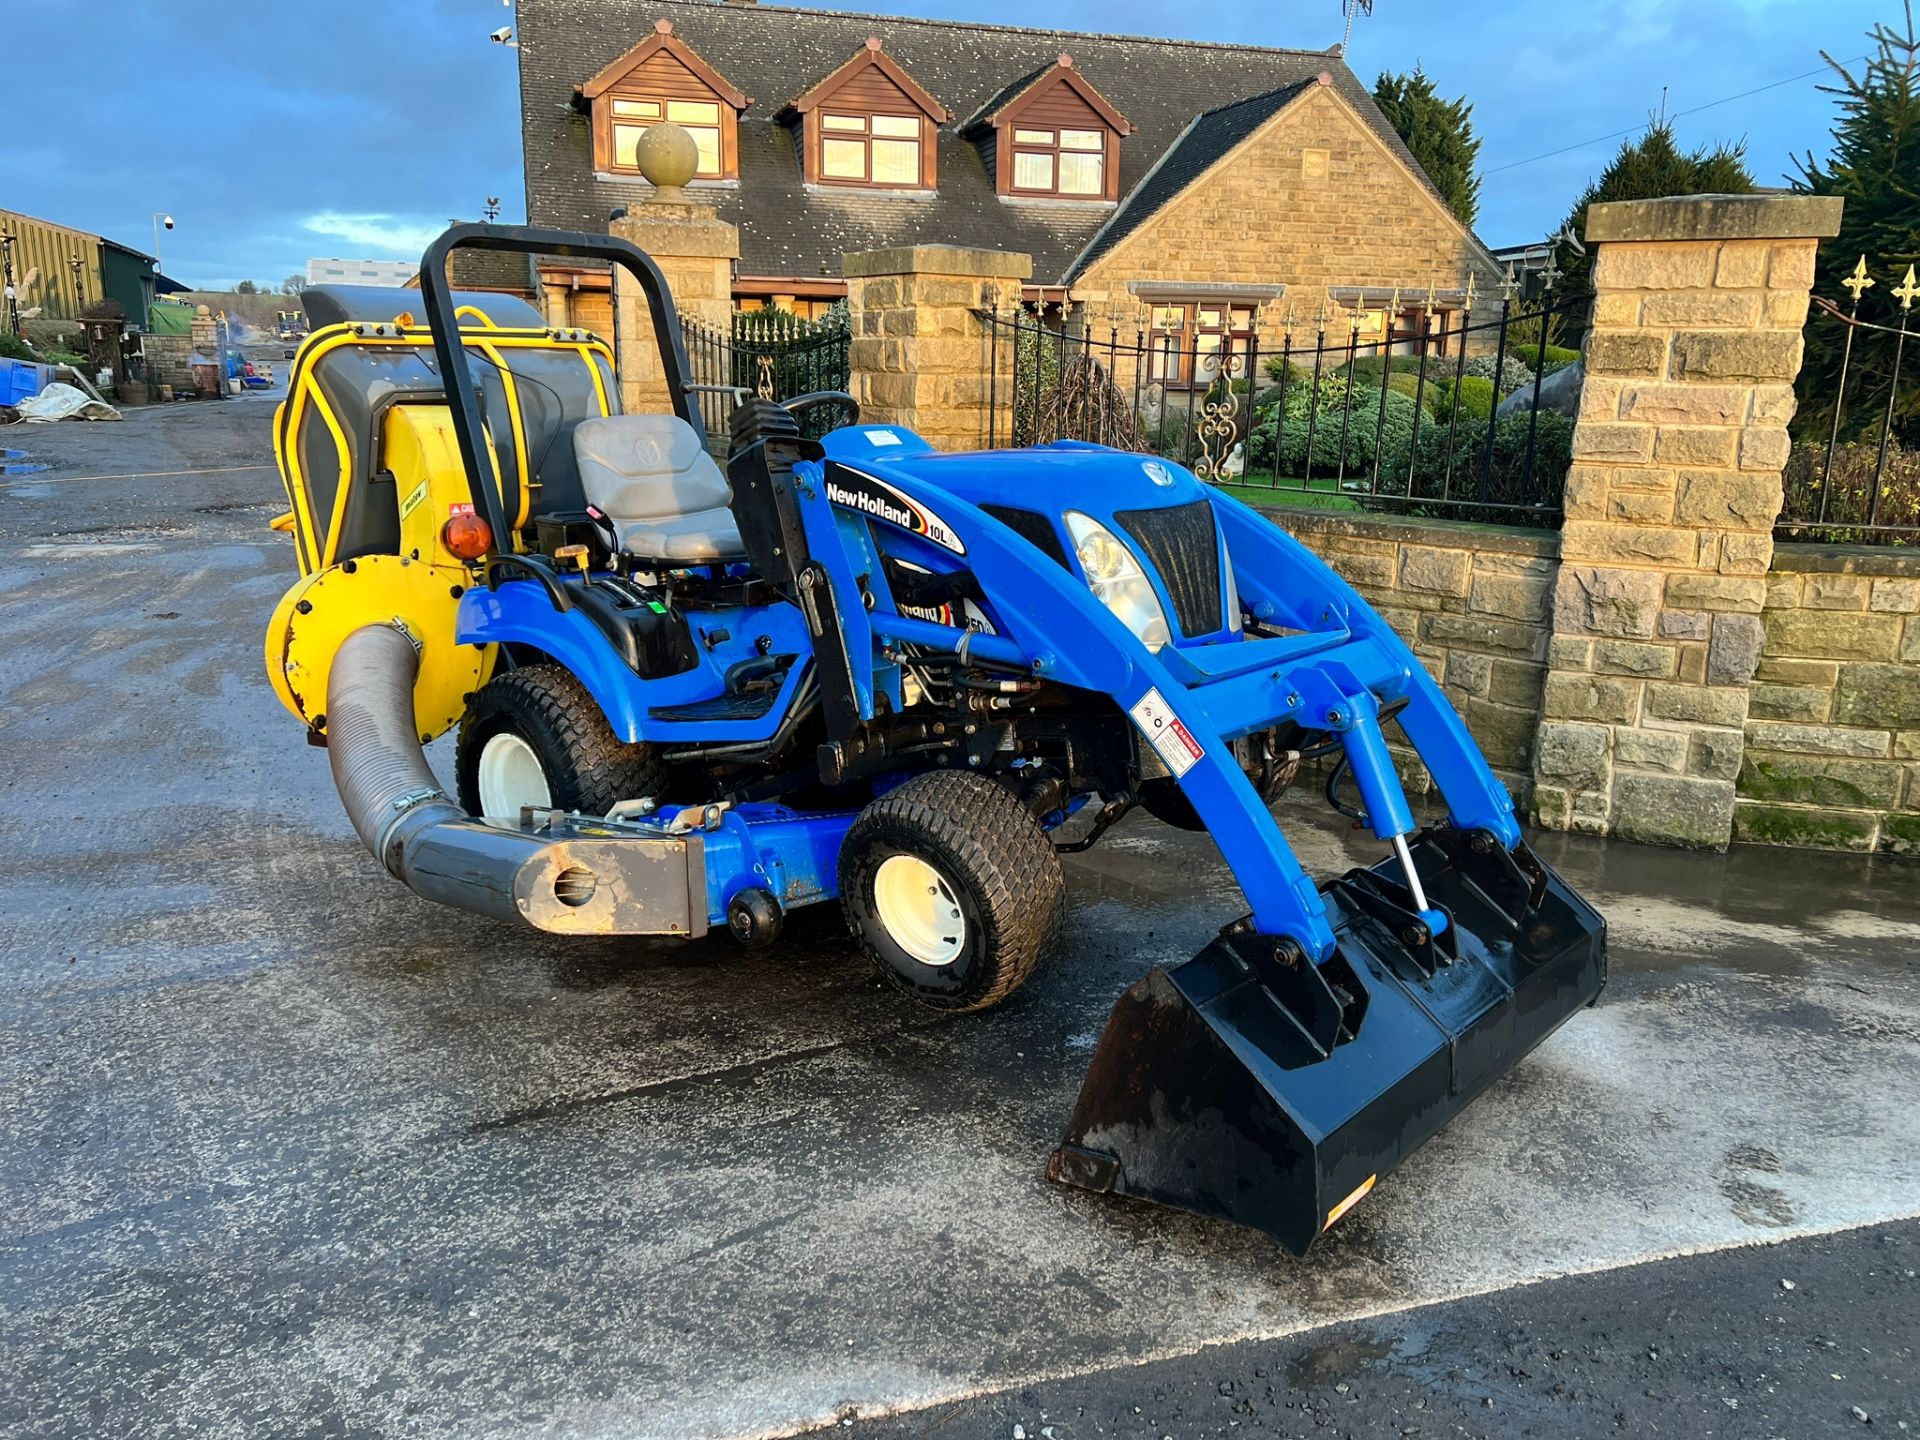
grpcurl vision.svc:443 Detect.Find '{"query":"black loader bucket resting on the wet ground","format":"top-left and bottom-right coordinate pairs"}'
top-left (1046, 829), bottom-right (1607, 1254)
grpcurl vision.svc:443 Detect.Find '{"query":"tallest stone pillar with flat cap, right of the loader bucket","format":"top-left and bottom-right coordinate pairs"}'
top-left (1532, 196), bottom-right (1841, 849)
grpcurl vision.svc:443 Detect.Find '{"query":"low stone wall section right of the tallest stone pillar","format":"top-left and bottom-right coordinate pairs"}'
top-left (1734, 545), bottom-right (1920, 854)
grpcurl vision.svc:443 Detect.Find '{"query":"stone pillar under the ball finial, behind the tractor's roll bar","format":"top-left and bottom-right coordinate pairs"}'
top-left (607, 198), bottom-right (739, 411)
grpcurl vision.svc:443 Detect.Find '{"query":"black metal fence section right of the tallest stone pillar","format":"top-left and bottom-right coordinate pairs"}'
top-left (1774, 257), bottom-right (1920, 545)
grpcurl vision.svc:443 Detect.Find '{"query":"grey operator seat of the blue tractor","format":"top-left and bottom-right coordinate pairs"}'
top-left (574, 415), bottom-right (747, 564)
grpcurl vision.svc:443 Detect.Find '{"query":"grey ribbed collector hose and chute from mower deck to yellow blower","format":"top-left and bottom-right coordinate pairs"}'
top-left (326, 624), bottom-right (707, 935)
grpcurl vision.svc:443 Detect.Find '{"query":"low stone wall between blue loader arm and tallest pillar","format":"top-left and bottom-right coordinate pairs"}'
top-left (1263, 507), bottom-right (1559, 806)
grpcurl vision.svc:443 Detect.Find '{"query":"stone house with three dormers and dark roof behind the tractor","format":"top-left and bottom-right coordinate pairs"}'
top-left (518, 0), bottom-right (1498, 366)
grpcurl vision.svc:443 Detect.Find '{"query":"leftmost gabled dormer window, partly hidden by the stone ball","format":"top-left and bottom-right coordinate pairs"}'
top-left (578, 19), bottom-right (753, 180)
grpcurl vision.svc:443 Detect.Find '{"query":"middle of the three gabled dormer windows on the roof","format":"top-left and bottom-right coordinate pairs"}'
top-left (780, 38), bottom-right (952, 190)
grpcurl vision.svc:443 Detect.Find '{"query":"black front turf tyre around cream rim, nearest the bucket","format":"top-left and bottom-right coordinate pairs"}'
top-left (839, 770), bottom-right (1066, 1012)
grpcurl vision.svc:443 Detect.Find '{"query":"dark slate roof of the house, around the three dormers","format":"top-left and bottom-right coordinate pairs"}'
top-left (516, 0), bottom-right (1443, 284)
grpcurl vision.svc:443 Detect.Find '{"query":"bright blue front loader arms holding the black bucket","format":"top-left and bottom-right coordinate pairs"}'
top-left (779, 461), bottom-right (1519, 962)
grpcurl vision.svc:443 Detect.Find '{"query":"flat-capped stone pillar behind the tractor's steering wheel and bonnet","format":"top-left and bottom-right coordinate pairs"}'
top-left (841, 246), bottom-right (1033, 449)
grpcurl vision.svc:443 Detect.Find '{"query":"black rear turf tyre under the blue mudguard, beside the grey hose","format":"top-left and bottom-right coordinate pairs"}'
top-left (453, 664), bottom-right (666, 816)
